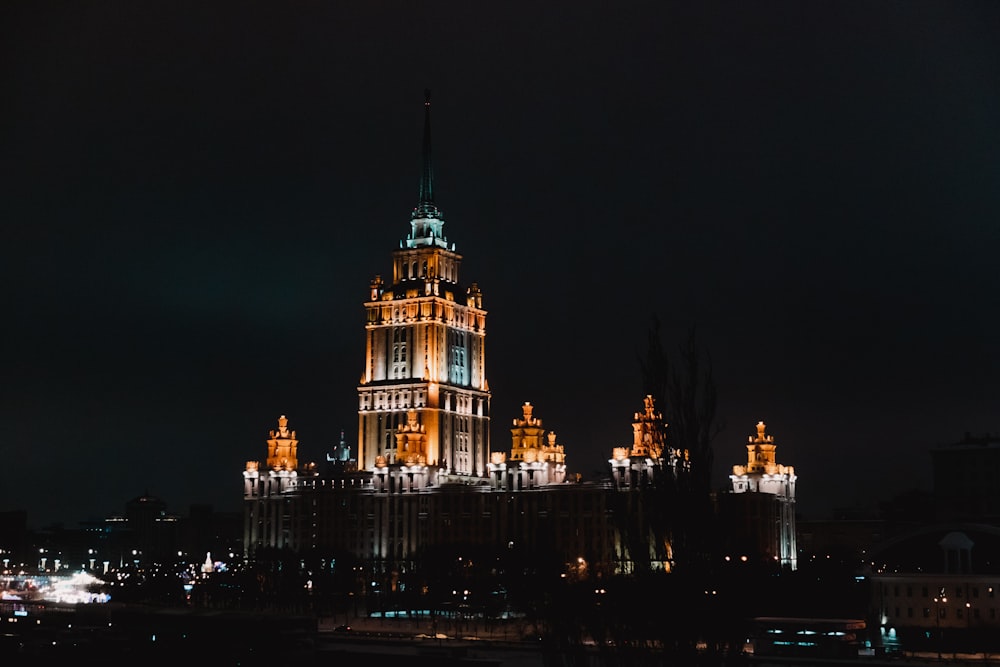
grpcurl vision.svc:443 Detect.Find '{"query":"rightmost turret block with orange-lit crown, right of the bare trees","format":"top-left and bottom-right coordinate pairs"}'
top-left (722, 421), bottom-right (798, 570)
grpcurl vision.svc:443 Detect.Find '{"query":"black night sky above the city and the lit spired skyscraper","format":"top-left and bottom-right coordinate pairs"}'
top-left (0, 0), bottom-right (1000, 525)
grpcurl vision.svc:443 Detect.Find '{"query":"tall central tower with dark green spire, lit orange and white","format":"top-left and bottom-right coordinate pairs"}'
top-left (358, 91), bottom-right (490, 476)
